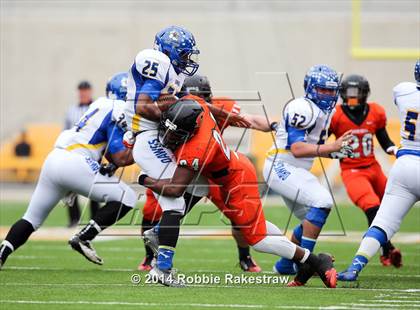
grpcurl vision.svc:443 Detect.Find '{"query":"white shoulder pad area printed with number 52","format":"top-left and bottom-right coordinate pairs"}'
top-left (284, 98), bottom-right (318, 129)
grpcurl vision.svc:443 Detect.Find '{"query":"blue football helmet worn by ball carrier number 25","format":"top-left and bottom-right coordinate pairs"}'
top-left (155, 26), bottom-right (200, 76)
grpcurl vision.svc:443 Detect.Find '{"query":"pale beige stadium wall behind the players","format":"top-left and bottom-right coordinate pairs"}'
top-left (0, 1), bottom-right (420, 138)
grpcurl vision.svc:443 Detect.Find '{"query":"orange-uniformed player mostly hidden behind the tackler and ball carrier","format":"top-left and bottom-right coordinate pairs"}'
top-left (138, 74), bottom-right (276, 272)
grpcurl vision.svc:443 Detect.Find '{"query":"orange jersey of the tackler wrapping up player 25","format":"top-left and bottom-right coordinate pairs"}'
top-left (175, 95), bottom-right (238, 184)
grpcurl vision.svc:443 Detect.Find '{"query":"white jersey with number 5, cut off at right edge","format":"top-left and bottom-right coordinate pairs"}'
top-left (393, 82), bottom-right (420, 151)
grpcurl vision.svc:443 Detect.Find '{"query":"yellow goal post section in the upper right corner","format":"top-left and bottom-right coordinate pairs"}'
top-left (351, 0), bottom-right (420, 60)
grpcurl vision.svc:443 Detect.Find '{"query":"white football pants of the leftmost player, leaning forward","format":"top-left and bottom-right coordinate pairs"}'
top-left (23, 148), bottom-right (137, 229)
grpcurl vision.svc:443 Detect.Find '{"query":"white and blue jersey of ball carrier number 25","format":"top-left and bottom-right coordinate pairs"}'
top-left (124, 49), bottom-right (185, 132)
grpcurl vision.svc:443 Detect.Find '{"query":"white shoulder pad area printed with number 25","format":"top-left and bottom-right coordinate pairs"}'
top-left (135, 49), bottom-right (171, 84)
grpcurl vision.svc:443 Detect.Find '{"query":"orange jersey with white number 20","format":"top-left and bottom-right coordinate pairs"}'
top-left (329, 102), bottom-right (386, 169)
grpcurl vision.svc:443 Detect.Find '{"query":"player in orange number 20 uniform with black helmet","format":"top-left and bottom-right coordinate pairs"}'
top-left (330, 74), bottom-right (401, 267)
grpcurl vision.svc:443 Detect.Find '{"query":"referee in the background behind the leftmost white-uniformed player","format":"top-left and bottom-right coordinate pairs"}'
top-left (64, 81), bottom-right (99, 227)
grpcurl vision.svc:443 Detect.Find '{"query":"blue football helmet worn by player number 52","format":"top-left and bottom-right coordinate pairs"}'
top-left (303, 65), bottom-right (339, 113)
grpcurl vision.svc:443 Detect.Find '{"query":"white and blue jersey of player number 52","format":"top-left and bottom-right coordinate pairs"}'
top-left (267, 97), bottom-right (335, 170)
